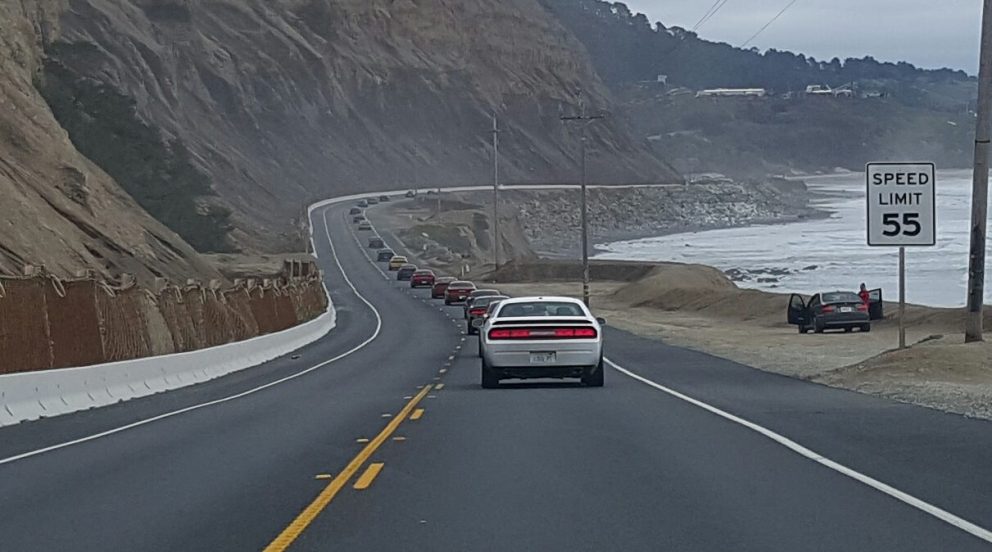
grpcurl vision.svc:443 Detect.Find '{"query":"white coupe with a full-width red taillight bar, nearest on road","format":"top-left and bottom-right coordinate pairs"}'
top-left (479, 297), bottom-right (606, 389)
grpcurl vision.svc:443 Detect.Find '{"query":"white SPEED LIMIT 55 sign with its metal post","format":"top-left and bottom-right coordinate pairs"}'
top-left (865, 163), bottom-right (937, 349)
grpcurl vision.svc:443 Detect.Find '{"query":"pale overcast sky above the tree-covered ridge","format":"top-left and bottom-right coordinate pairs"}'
top-left (624, 0), bottom-right (982, 74)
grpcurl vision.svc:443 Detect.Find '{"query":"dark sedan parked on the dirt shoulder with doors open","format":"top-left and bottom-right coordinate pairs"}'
top-left (788, 291), bottom-right (871, 333)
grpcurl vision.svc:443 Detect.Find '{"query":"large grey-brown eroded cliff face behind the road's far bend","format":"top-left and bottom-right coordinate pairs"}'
top-left (48, 0), bottom-right (679, 250)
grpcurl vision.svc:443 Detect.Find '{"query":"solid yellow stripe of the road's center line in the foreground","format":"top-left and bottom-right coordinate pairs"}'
top-left (264, 385), bottom-right (433, 552)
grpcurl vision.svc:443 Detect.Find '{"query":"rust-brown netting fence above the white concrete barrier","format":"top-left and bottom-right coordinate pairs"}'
top-left (0, 261), bottom-right (327, 374)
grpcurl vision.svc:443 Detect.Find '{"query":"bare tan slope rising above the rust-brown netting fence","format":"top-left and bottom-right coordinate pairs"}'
top-left (0, 0), bottom-right (217, 279)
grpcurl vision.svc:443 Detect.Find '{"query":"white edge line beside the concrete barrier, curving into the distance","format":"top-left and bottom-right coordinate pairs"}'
top-left (0, 208), bottom-right (382, 466)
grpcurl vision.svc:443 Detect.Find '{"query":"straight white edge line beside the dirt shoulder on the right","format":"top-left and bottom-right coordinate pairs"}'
top-left (604, 359), bottom-right (992, 543)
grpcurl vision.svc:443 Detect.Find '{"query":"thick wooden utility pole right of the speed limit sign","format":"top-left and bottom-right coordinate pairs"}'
top-left (964, 0), bottom-right (992, 343)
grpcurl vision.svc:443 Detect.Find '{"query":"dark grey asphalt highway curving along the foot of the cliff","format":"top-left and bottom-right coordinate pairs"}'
top-left (0, 201), bottom-right (992, 552)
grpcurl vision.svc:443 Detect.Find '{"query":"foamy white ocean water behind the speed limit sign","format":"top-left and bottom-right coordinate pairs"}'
top-left (595, 170), bottom-right (992, 307)
